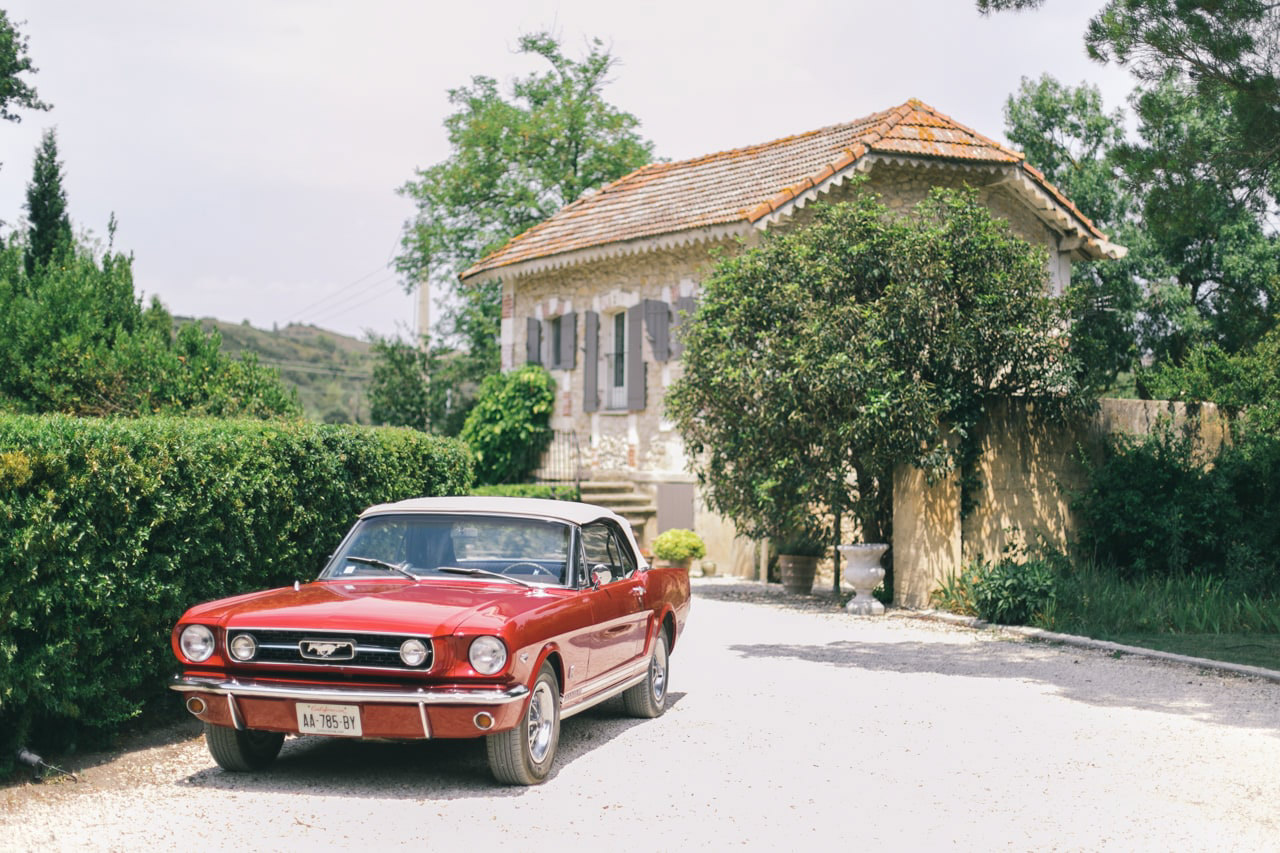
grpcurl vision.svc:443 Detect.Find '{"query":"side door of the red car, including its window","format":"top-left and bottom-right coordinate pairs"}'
top-left (582, 521), bottom-right (649, 679)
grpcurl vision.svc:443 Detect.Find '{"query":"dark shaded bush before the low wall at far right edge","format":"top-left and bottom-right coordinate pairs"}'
top-left (1071, 417), bottom-right (1280, 593)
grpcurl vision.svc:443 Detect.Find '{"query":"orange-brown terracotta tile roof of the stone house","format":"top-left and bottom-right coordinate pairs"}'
top-left (462, 100), bottom-right (1105, 278)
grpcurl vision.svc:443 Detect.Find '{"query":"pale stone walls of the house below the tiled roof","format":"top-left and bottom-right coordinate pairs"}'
top-left (502, 161), bottom-right (1070, 576)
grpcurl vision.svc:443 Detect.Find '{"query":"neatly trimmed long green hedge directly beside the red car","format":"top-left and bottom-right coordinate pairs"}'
top-left (0, 415), bottom-right (472, 772)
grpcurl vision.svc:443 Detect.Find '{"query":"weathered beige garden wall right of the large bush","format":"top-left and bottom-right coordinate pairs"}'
top-left (893, 400), bottom-right (1226, 607)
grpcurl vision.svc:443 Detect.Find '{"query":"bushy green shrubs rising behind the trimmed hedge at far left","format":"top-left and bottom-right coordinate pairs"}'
top-left (0, 238), bottom-right (300, 418)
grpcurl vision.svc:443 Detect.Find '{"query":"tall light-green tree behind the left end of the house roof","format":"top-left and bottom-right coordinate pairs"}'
top-left (397, 33), bottom-right (653, 286)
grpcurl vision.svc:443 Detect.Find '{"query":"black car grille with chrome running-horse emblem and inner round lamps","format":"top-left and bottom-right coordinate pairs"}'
top-left (227, 629), bottom-right (435, 672)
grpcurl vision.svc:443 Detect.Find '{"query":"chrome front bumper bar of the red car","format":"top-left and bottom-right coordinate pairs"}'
top-left (169, 675), bottom-right (529, 701)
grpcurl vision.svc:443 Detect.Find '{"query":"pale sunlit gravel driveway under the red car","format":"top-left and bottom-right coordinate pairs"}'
top-left (0, 580), bottom-right (1280, 852)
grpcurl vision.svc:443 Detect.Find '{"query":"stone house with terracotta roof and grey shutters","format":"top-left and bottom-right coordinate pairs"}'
top-left (462, 100), bottom-right (1124, 575)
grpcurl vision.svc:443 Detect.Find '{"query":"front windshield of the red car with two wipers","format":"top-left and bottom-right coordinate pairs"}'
top-left (320, 515), bottom-right (572, 585)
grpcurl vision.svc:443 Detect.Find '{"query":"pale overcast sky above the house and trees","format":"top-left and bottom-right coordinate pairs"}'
top-left (0, 0), bottom-right (1132, 336)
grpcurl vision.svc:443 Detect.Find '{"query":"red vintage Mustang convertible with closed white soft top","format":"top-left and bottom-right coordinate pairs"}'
top-left (172, 497), bottom-right (689, 785)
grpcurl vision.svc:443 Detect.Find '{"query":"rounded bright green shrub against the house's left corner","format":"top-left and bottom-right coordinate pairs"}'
top-left (461, 365), bottom-right (556, 484)
